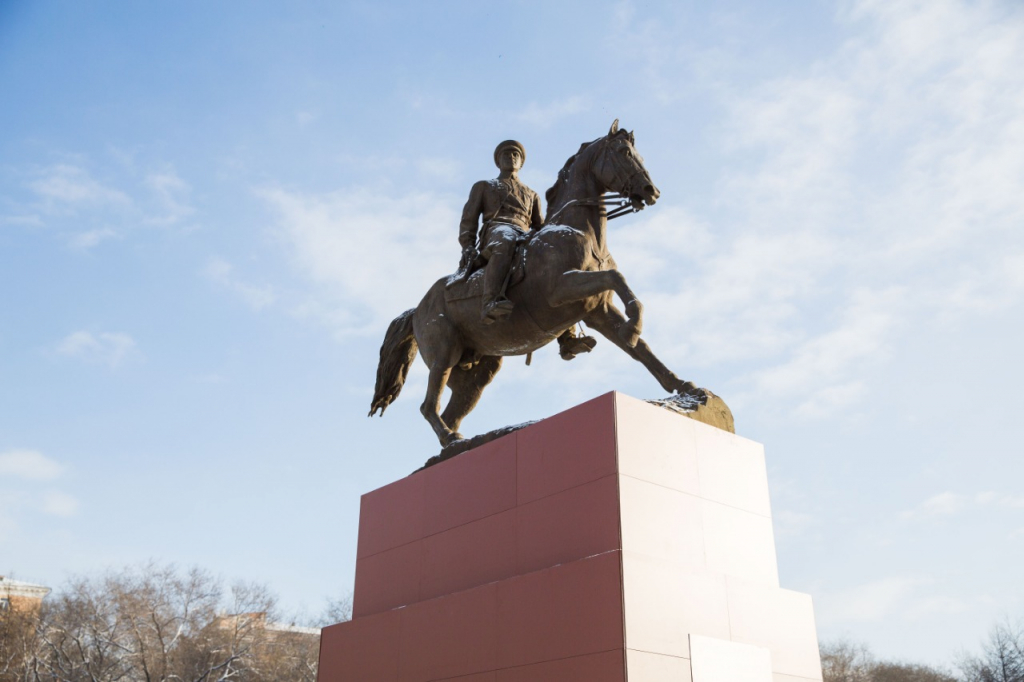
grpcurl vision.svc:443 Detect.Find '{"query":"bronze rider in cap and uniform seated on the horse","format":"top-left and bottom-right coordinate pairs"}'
top-left (459, 139), bottom-right (595, 359)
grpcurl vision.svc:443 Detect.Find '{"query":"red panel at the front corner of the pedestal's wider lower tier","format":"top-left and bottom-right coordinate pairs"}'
top-left (497, 552), bottom-right (623, 669)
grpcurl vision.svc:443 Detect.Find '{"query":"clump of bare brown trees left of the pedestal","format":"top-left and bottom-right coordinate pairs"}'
top-left (0, 564), bottom-right (319, 682)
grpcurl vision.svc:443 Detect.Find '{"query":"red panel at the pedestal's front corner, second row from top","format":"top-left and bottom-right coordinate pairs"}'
top-left (516, 475), bottom-right (622, 573)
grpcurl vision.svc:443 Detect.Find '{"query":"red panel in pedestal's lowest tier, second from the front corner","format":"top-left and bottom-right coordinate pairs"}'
top-left (396, 583), bottom-right (499, 682)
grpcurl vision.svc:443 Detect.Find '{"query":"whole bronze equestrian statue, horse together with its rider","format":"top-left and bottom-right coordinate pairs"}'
top-left (370, 120), bottom-right (709, 447)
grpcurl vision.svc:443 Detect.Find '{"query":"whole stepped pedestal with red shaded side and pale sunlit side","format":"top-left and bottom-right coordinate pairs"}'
top-left (318, 393), bottom-right (821, 682)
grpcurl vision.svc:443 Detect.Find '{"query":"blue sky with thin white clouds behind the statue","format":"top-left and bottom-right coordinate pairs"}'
top-left (0, 0), bottom-right (1024, 663)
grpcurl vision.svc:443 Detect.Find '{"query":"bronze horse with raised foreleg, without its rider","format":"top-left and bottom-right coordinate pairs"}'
top-left (370, 121), bottom-right (708, 446)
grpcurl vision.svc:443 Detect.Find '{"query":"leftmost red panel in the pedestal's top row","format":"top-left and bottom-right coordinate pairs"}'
top-left (356, 472), bottom-right (426, 558)
